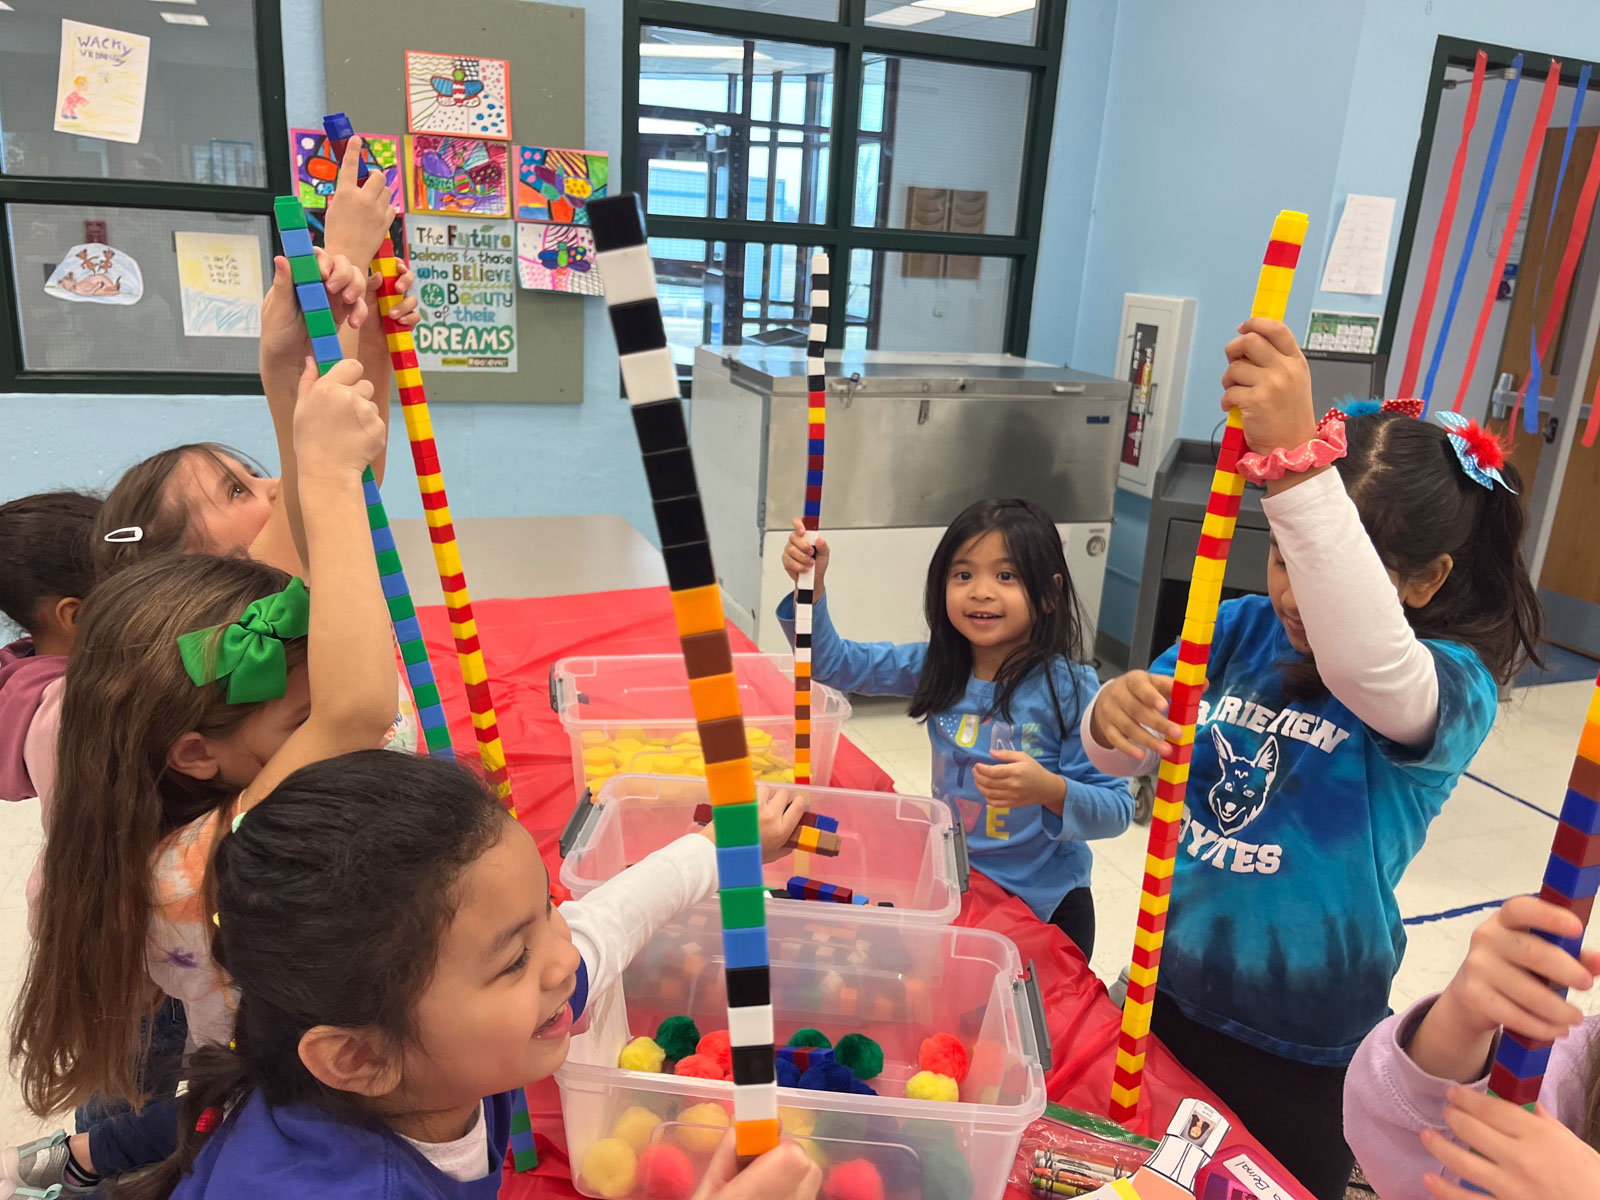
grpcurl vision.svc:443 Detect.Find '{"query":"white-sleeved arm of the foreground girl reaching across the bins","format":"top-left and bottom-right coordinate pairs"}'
top-left (562, 789), bottom-right (806, 994)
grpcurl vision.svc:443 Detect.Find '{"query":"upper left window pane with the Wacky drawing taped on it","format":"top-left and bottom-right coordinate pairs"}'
top-left (0, 0), bottom-right (268, 187)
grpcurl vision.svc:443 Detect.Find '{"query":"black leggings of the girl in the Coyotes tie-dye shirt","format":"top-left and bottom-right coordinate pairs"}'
top-left (1152, 990), bottom-right (1355, 1200)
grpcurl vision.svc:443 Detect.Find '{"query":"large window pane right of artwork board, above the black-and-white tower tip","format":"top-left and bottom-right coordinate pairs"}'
top-left (638, 26), bottom-right (834, 224)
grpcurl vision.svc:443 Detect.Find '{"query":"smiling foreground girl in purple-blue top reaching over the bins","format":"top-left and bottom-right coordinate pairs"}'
top-left (123, 752), bottom-right (821, 1200)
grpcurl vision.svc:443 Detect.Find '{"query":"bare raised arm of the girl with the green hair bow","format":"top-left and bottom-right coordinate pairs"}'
top-left (242, 358), bottom-right (397, 808)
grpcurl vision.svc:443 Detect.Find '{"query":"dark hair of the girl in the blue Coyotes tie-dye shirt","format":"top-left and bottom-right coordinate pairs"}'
top-left (1285, 413), bottom-right (1544, 699)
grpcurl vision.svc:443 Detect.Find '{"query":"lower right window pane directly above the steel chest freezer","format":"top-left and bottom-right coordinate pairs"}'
top-left (845, 250), bottom-right (1011, 352)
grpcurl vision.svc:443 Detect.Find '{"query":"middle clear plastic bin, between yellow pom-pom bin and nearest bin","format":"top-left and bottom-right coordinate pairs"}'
top-left (562, 774), bottom-right (968, 925)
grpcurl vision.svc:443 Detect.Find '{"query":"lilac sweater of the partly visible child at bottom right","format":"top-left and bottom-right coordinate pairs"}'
top-left (1344, 995), bottom-right (1600, 1200)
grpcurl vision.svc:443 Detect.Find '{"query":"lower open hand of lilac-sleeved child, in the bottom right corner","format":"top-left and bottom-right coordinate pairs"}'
top-left (1422, 1088), bottom-right (1600, 1200)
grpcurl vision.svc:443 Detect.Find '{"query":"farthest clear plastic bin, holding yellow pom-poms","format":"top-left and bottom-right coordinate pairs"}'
top-left (550, 654), bottom-right (850, 795)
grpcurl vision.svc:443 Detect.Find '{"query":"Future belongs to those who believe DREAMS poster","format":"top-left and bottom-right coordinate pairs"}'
top-left (406, 216), bottom-right (517, 371)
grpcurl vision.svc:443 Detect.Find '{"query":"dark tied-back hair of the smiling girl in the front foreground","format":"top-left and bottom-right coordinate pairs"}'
top-left (117, 750), bottom-right (510, 1200)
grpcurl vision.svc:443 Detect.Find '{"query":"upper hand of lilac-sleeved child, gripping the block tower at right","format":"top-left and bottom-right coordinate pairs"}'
top-left (1429, 896), bottom-right (1600, 1042)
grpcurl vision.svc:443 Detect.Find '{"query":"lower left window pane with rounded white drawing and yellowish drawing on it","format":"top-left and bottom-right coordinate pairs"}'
top-left (5, 205), bottom-right (274, 374)
